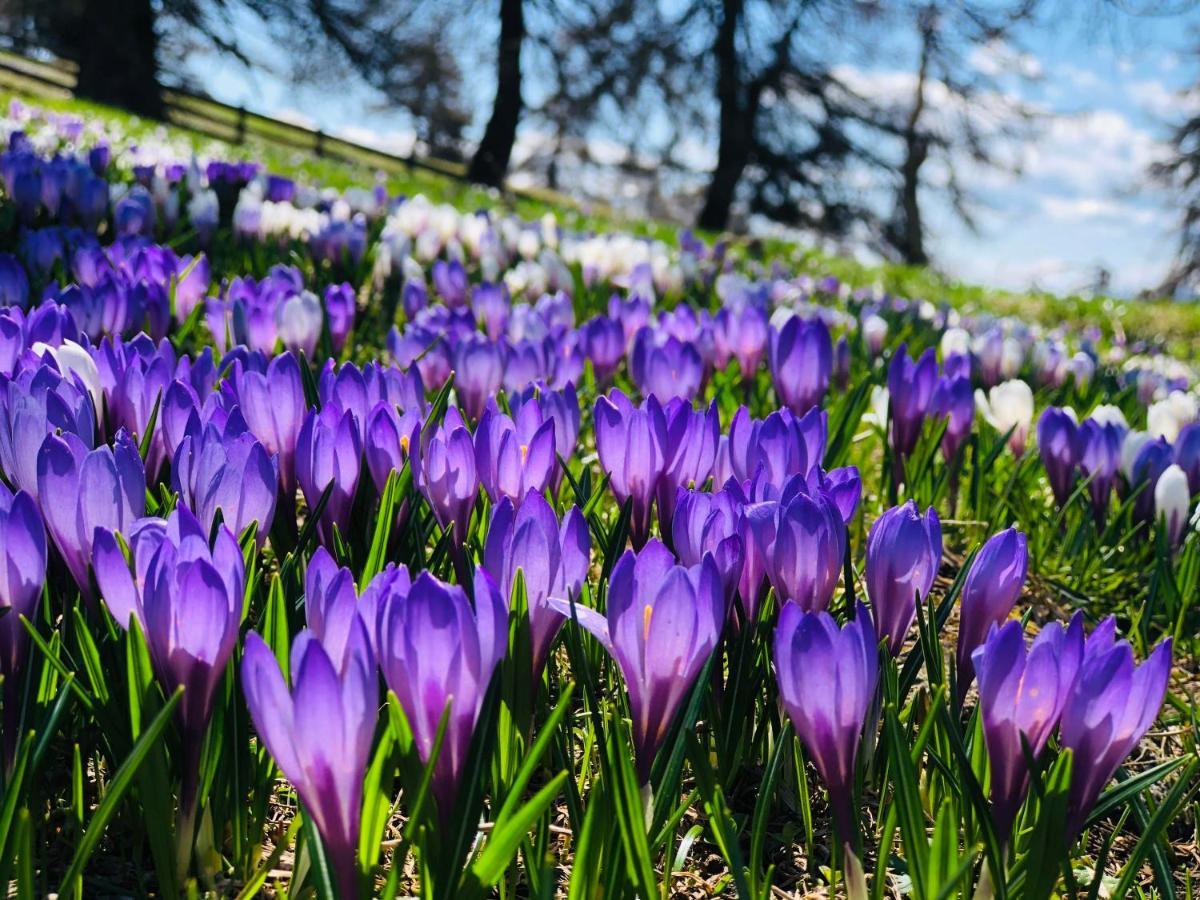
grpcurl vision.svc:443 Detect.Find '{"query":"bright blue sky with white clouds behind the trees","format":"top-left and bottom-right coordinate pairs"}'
top-left (187, 7), bottom-right (1200, 300)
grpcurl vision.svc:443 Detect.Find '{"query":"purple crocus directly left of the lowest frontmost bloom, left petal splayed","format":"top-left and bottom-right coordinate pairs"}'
top-left (92, 506), bottom-right (246, 823)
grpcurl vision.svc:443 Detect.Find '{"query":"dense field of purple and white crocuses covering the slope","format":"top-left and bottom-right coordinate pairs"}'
top-left (0, 102), bottom-right (1185, 896)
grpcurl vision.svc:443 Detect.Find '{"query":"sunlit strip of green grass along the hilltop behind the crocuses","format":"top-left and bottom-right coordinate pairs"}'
top-left (9, 90), bottom-right (1200, 360)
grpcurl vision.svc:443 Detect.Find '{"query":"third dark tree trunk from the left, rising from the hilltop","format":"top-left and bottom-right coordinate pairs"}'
top-left (696, 0), bottom-right (754, 232)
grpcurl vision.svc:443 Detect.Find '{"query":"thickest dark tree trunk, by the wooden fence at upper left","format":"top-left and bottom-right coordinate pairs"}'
top-left (50, 0), bottom-right (163, 118)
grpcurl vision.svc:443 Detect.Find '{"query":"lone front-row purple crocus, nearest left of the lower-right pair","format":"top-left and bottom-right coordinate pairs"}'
top-left (773, 604), bottom-right (880, 846)
